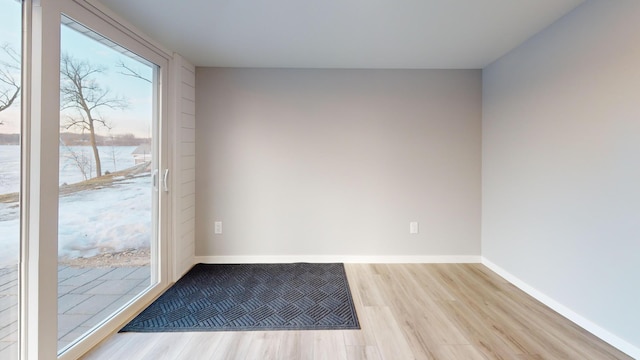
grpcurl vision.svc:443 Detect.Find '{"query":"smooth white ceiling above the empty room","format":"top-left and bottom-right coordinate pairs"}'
top-left (100, 0), bottom-right (584, 69)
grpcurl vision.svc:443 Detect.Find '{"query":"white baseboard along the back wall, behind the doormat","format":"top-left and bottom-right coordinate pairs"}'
top-left (195, 255), bottom-right (481, 264)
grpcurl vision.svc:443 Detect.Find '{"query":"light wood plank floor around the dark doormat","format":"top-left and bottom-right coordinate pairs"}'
top-left (80, 264), bottom-right (631, 360)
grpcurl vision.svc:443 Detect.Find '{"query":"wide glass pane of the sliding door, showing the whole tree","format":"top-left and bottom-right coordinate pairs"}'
top-left (58, 17), bottom-right (159, 351)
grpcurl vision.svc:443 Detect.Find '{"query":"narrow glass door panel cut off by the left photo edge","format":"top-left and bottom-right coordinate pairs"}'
top-left (0, 0), bottom-right (22, 360)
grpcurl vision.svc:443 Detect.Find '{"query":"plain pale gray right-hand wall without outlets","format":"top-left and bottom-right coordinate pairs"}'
top-left (482, 0), bottom-right (640, 356)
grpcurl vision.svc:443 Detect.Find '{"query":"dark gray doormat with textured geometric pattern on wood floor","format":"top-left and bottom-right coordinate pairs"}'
top-left (120, 263), bottom-right (360, 332)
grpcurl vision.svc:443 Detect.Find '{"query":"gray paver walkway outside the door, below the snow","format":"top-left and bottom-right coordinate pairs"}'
top-left (0, 266), bottom-right (150, 359)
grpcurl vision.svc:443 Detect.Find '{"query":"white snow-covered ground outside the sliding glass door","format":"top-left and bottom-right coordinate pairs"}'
top-left (0, 146), bottom-right (153, 266)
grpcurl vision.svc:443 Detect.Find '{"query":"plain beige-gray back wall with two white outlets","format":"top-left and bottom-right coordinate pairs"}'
top-left (196, 68), bottom-right (482, 258)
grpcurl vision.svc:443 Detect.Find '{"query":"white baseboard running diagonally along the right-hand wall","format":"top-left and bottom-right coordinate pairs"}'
top-left (481, 257), bottom-right (640, 359)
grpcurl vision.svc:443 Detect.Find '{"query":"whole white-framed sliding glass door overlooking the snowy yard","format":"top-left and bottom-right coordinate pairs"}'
top-left (0, 0), bottom-right (171, 360)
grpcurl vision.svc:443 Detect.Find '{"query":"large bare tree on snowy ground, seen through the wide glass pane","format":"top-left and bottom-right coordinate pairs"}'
top-left (60, 54), bottom-right (129, 176)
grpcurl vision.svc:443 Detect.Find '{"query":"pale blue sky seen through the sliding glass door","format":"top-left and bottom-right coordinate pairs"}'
top-left (0, 0), bottom-right (153, 138)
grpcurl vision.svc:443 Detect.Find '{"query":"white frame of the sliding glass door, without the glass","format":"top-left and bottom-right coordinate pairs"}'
top-left (21, 0), bottom-right (175, 359)
